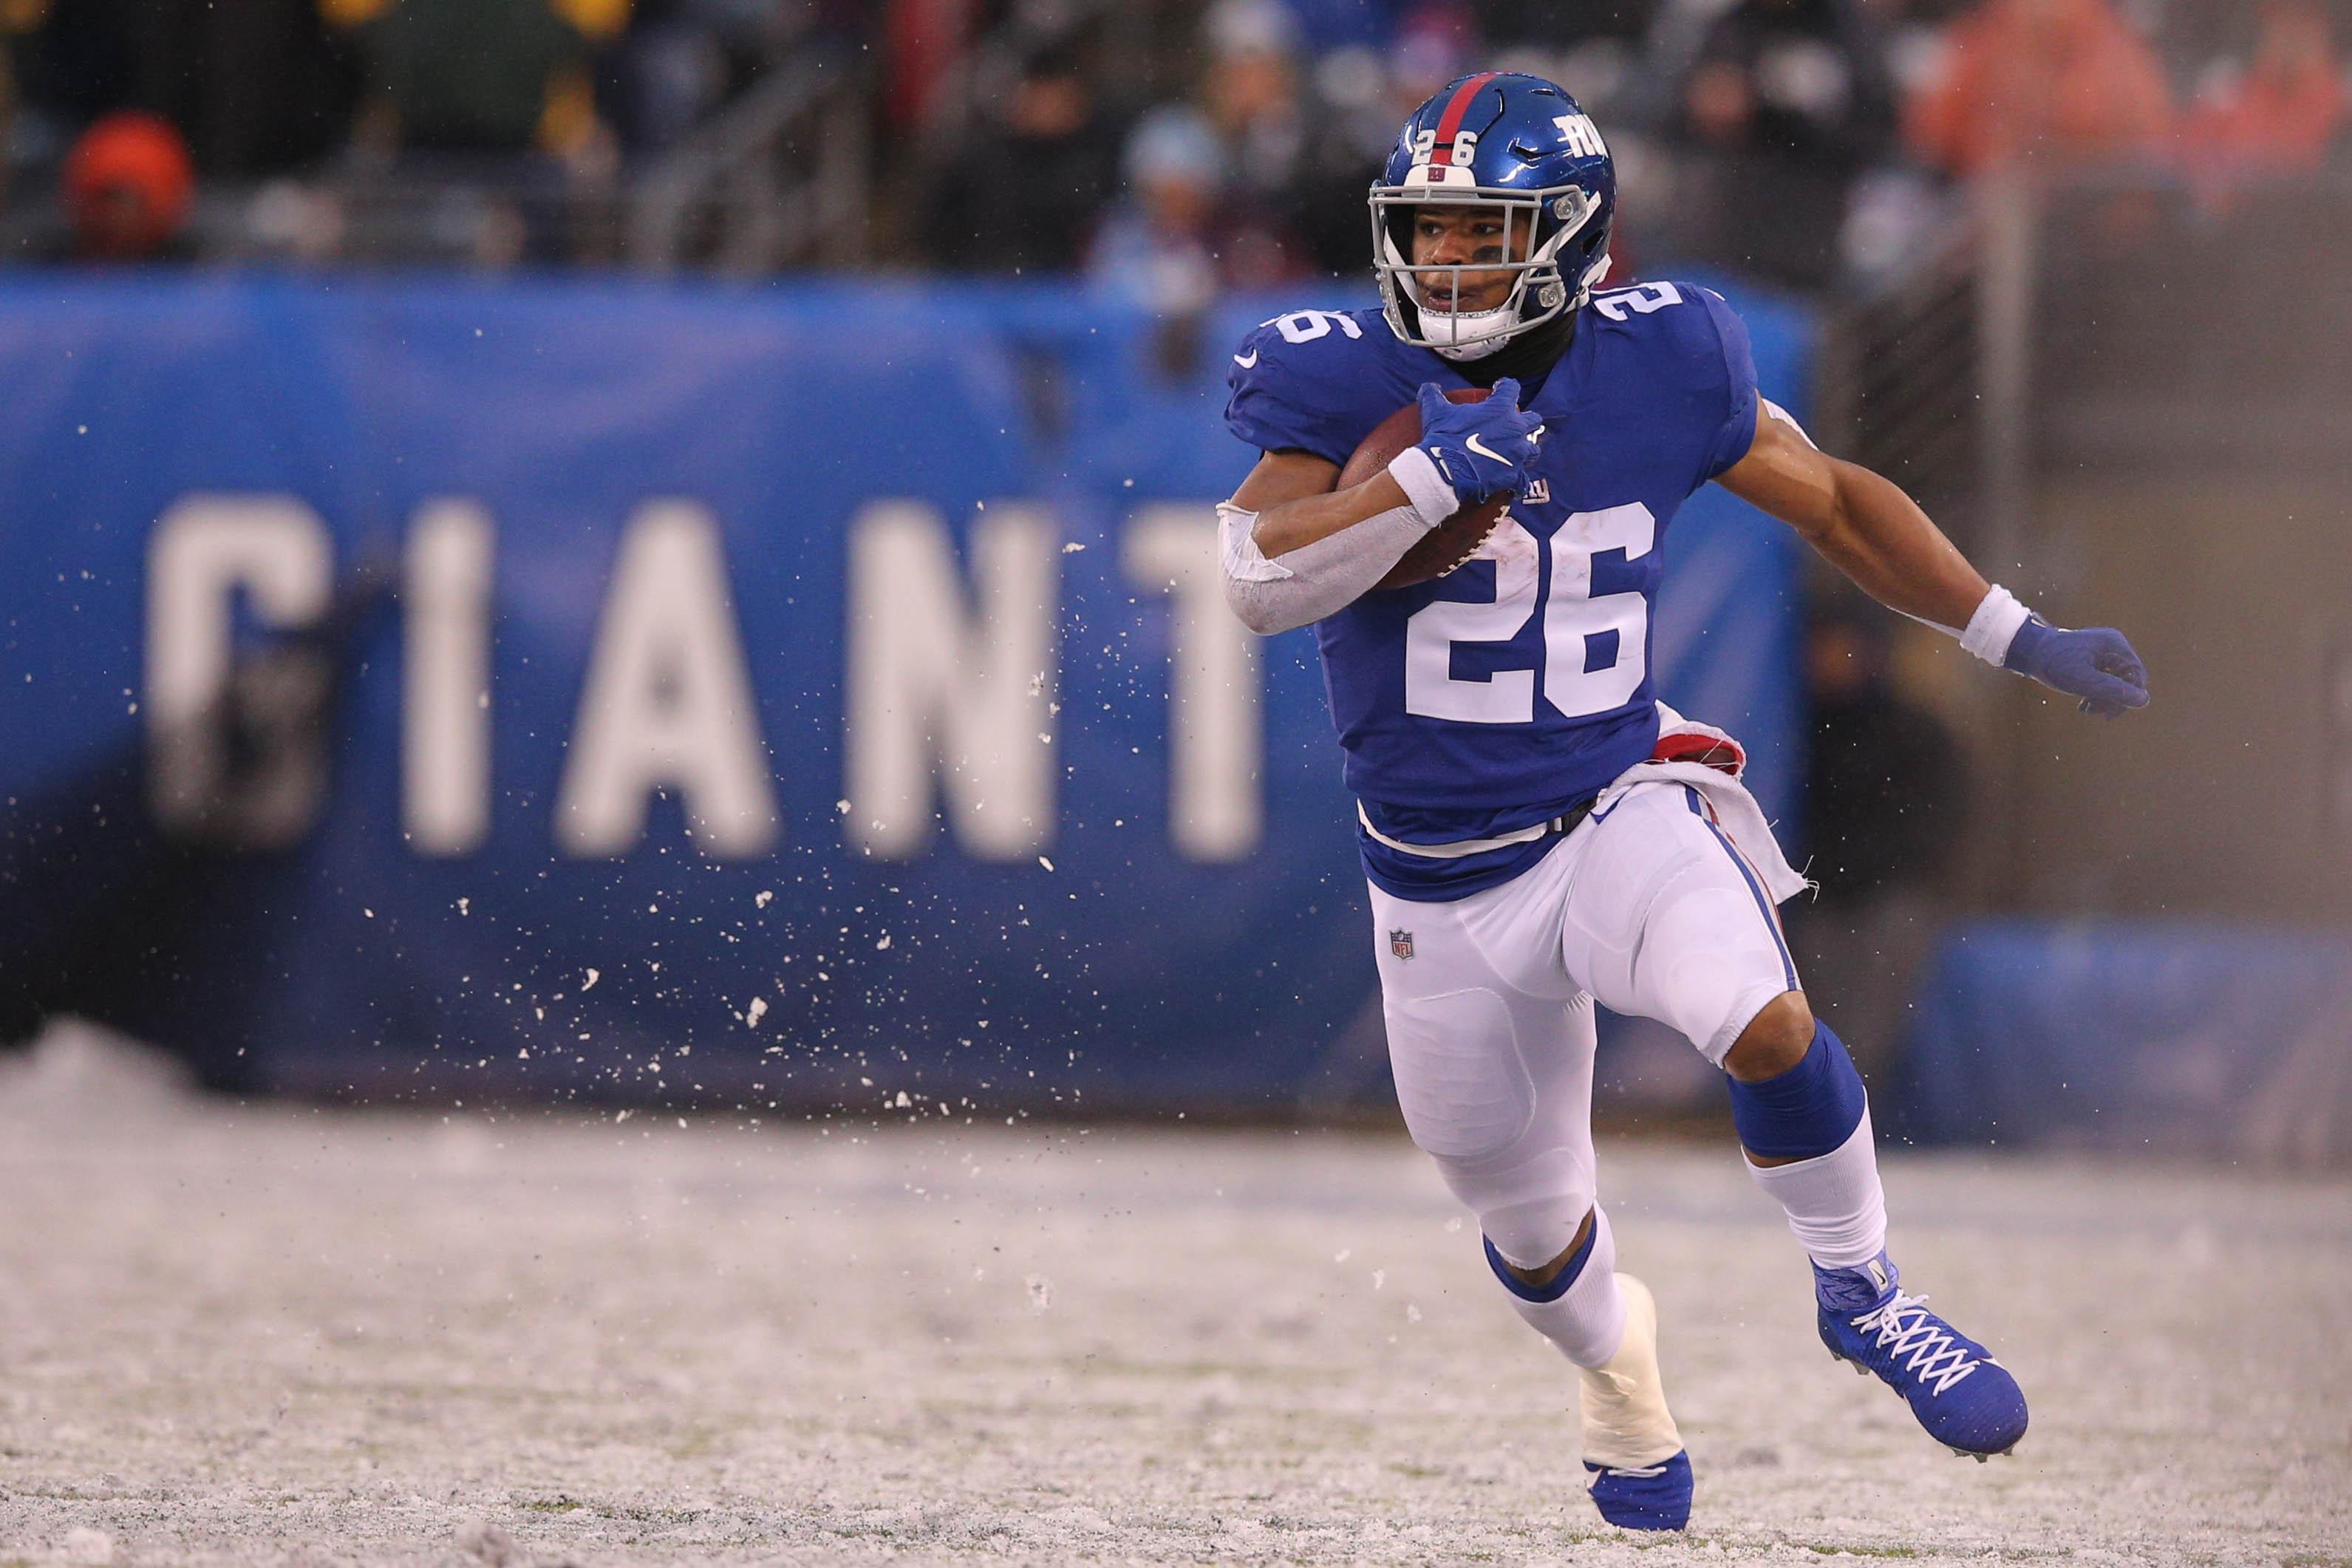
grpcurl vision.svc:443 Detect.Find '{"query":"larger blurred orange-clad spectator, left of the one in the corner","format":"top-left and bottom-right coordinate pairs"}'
top-left (1907, 0), bottom-right (2171, 177)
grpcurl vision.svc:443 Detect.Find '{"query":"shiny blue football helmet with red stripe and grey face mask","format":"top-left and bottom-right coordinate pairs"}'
top-left (1371, 70), bottom-right (1616, 360)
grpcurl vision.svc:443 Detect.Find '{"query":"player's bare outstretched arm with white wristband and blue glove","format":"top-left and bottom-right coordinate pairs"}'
top-left (1719, 400), bottom-right (2147, 720)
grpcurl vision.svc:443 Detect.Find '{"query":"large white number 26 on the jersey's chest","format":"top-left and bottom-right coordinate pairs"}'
top-left (1404, 501), bottom-right (1658, 724)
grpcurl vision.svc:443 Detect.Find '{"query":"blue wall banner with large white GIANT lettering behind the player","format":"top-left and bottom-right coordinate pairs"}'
top-left (0, 273), bottom-right (1809, 1117)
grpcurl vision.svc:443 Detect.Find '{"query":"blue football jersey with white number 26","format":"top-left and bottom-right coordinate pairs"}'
top-left (1225, 282), bottom-right (1757, 900)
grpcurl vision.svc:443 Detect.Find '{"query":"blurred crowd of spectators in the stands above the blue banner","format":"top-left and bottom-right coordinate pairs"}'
top-left (0, 0), bottom-right (2352, 285)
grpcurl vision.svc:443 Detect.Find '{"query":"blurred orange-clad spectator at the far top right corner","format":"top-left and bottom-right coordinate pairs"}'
top-left (2185, 0), bottom-right (2345, 195)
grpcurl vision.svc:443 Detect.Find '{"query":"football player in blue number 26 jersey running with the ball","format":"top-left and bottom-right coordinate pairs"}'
top-left (1218, 70), bottom-right (2147, 1530)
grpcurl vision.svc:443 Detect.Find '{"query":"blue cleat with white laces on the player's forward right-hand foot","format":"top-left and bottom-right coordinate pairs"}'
top-left (1813, 1253), bottom-right (2025, 1465)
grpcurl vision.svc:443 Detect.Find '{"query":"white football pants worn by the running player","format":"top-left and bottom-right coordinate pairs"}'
top-left (1371, 783), bottom-right (1797, 1269)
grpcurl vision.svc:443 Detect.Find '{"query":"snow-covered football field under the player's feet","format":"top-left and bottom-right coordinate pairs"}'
top-left (0, 1034), bottom-right (2352, 1568)
